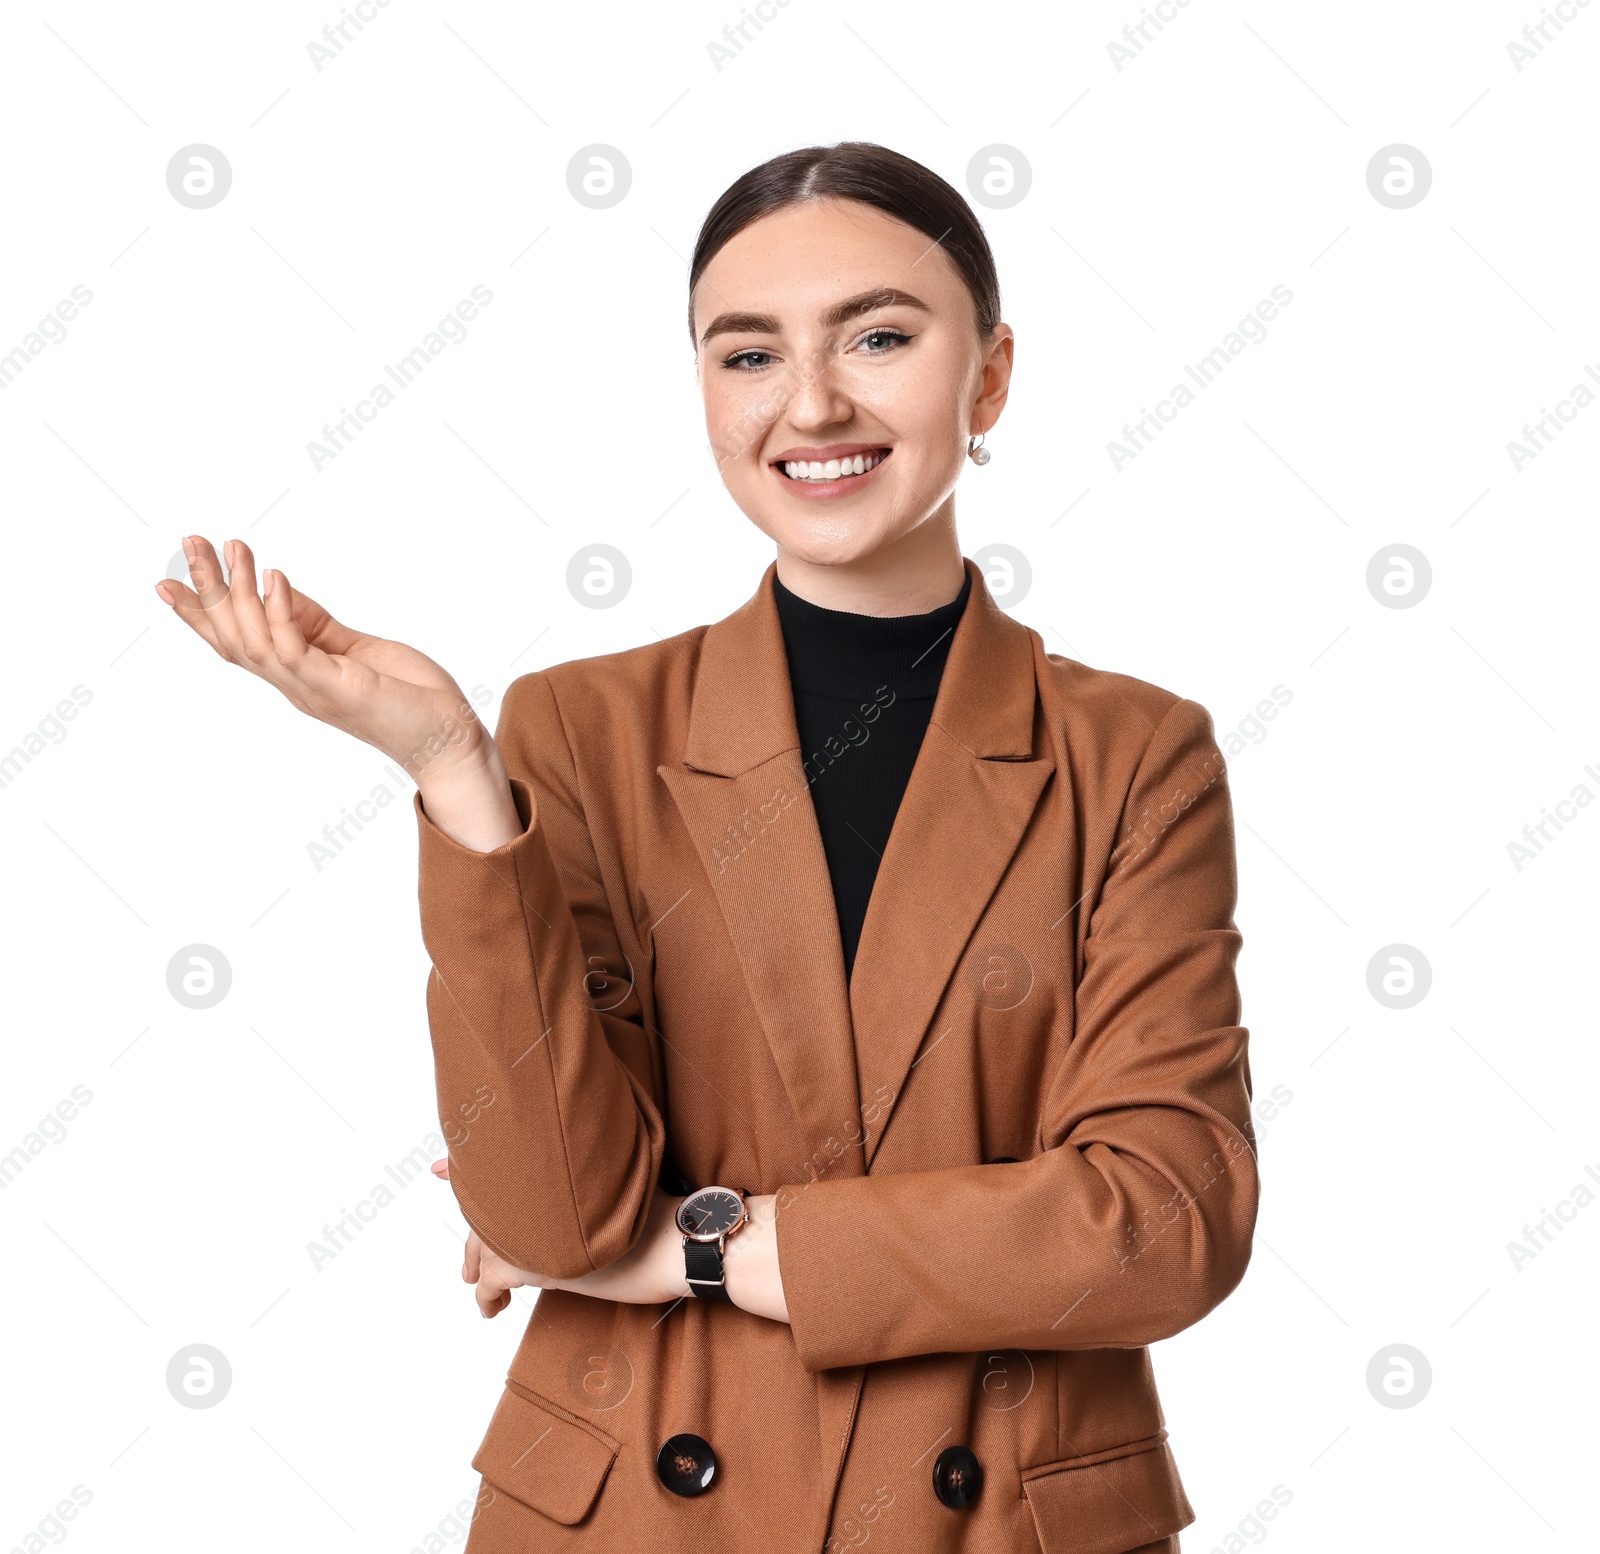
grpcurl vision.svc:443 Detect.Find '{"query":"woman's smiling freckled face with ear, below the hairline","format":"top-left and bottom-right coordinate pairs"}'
top-left (693, 198), bottom-right (1013, 565)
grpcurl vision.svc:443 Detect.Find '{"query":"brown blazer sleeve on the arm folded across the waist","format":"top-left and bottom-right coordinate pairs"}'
top-left (776, 699), bottom-right (1258, 1372)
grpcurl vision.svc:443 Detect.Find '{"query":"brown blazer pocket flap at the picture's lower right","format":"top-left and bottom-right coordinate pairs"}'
top-left (1022, 1440), bottom-right (1195, 1554)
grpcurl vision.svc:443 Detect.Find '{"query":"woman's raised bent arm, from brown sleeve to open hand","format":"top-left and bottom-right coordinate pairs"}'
top-left (155, 536), bottom-right (666, 1277)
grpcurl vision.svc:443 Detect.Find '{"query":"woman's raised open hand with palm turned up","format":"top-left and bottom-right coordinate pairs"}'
top-left (155, 535), bottom-right (488, 778)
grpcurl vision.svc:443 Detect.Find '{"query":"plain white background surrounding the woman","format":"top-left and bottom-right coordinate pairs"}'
top-left (0, 0), bottom-right (1600, 1554)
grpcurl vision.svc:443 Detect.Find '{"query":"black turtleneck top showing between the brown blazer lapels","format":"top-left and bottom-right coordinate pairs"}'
top-left (773, 568), bottom-right (973, 979)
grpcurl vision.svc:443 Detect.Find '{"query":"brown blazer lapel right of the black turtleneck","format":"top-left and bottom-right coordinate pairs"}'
top-left (850, 559), bottom-right (1070, 1170)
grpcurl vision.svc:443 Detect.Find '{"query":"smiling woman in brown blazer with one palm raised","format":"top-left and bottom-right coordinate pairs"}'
top-left (158, 144), bottom-right (1258, 1554)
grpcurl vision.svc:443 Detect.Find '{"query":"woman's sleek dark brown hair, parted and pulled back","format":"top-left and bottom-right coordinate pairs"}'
top-left (690, 141), bottom-right (1000, 339)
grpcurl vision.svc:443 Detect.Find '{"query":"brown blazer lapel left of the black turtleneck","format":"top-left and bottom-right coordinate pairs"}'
top-left (656, 563), bottom-right (866, 1176)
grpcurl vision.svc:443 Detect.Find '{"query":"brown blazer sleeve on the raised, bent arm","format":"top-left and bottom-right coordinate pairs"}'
top-left (413, 674), bottom-right (666, 1279)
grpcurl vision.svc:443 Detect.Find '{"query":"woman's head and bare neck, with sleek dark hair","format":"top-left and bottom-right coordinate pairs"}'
top-left (690, 146), bottom-right (1013, 598)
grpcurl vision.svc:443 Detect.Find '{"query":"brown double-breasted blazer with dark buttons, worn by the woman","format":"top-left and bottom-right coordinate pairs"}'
top-left (416, 560), bottom-right (1258, 1554)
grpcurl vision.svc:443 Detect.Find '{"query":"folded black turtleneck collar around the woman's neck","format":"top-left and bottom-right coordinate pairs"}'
top-left (773, 568), bottom-right (973, 698)
